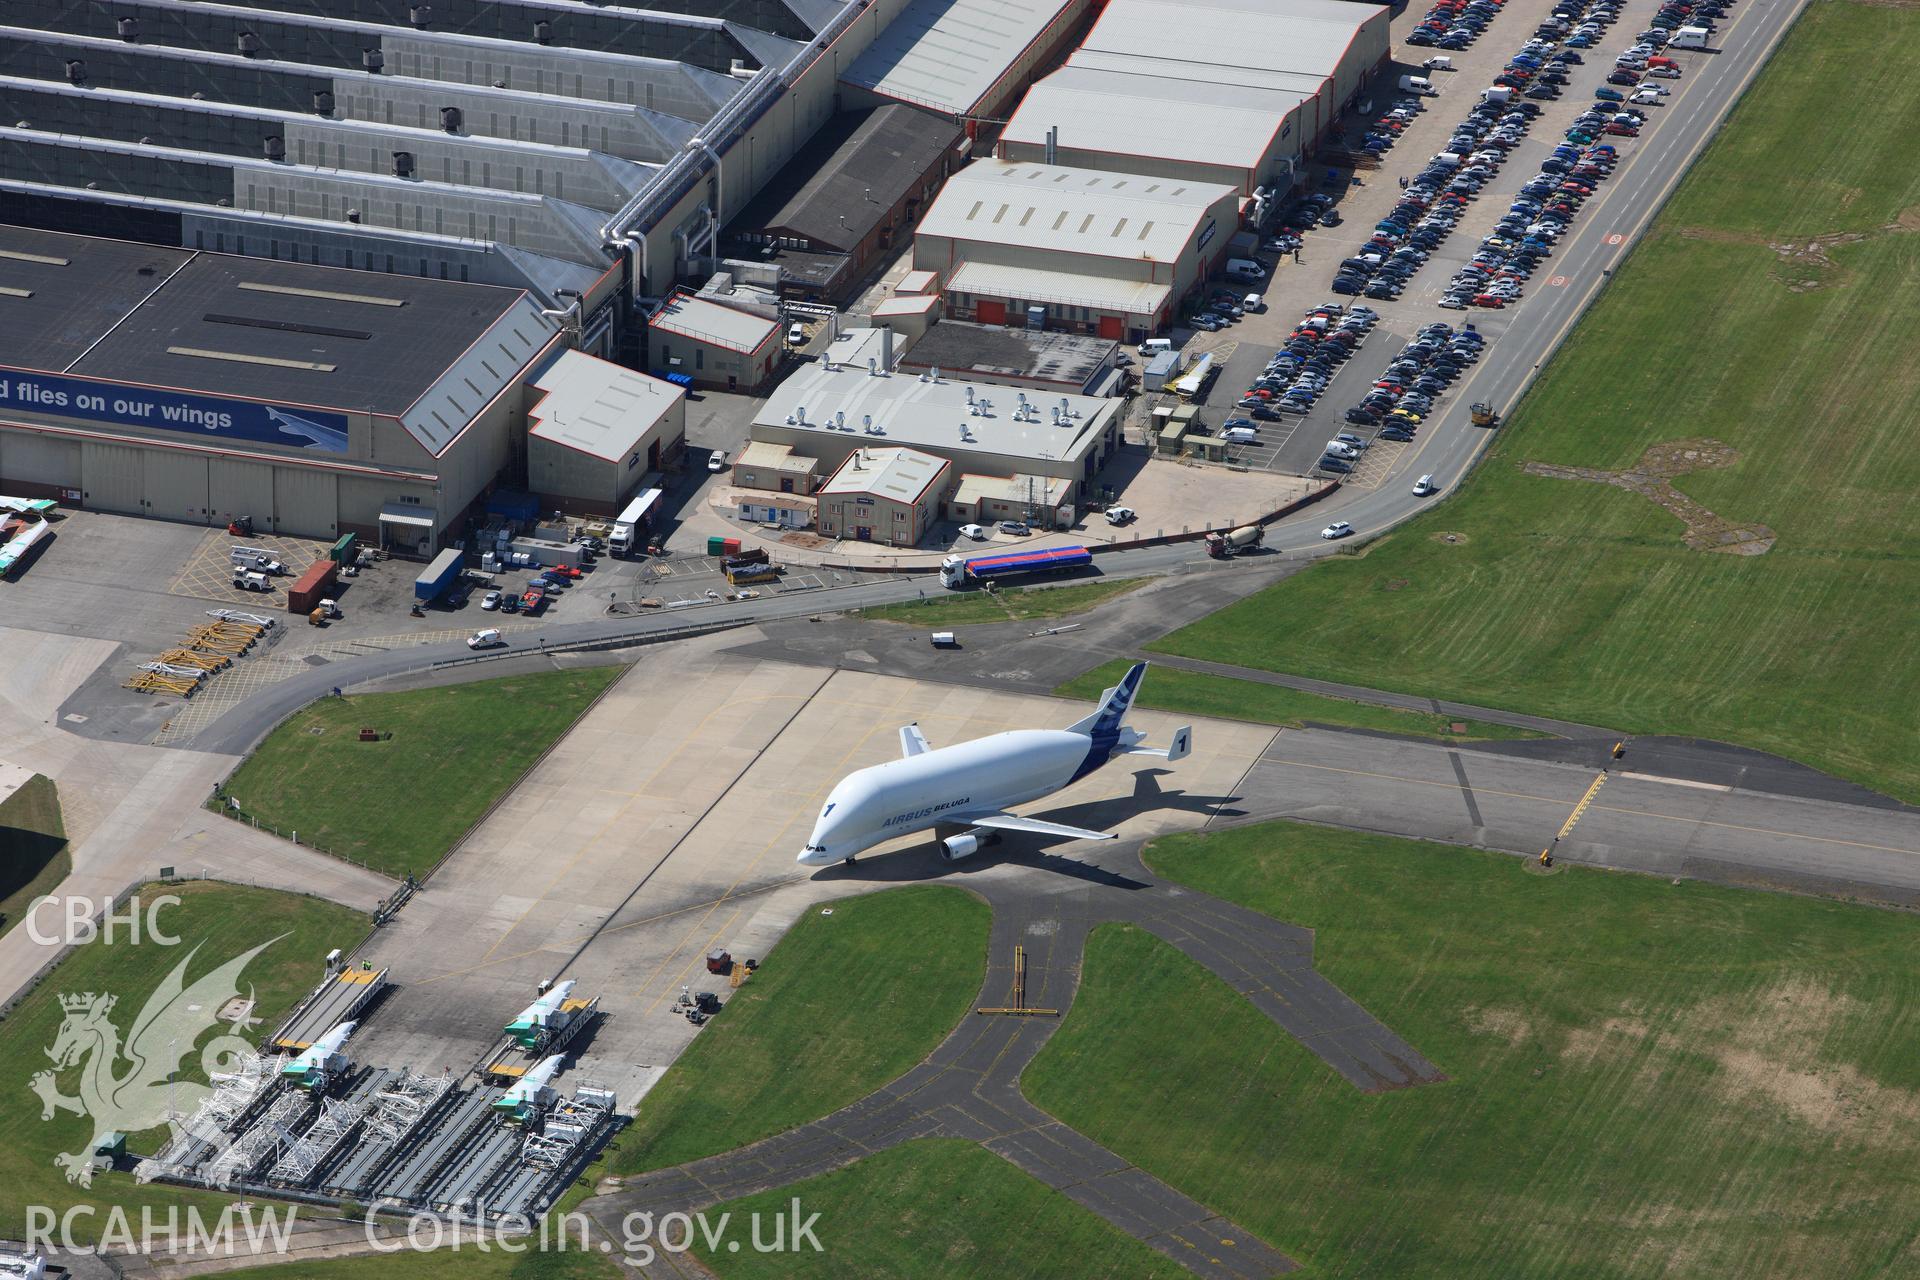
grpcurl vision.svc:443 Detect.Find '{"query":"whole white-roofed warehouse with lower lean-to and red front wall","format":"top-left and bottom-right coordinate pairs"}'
top-left (914, 159), bottom-right (1240, 342)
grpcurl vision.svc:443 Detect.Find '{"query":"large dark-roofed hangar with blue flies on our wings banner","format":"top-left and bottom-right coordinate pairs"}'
top-left (0, 226), bottom-right (564, 555)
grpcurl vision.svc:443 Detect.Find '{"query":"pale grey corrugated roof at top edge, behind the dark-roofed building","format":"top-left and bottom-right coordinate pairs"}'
top-left (841, 0), bottom-right (1090, 115)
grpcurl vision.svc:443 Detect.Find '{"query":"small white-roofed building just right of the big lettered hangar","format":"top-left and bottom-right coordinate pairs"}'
top-left (526, 351), bottom-right (687, 514)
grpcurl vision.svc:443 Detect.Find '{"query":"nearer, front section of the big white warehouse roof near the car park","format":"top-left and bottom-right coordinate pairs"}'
top-left (1000, 61), bottom-right (1311, 169)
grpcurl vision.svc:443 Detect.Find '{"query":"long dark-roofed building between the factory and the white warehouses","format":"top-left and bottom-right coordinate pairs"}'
top-left (732, 102), bottom-right (964, 301)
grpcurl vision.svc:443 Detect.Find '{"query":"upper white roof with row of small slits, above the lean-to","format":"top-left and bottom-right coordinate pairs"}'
top-left (920, 159), bottom-right (1235, 268)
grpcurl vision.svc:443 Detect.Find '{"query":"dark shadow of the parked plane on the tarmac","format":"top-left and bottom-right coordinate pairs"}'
top-left (814, 770), bottom-right (1244, 889)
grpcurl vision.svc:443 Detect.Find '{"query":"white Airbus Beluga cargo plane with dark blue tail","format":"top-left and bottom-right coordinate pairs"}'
top-left (797, 662), bottom-right (1192, 867)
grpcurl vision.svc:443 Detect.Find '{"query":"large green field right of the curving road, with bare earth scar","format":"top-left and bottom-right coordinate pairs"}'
top-left (1162, 0), bottom-right (1920, 800)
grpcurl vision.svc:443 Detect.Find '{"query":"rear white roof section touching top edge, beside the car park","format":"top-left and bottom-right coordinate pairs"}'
top-left (1083, 0), bottom-right (1386, 79)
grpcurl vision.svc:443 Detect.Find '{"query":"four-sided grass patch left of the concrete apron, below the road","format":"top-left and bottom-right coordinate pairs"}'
top-left (225, 666), bottom-right (626, 877)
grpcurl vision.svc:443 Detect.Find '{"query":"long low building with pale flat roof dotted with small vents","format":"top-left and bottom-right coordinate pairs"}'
top-left (751, 326), bottom-right (1119, 497)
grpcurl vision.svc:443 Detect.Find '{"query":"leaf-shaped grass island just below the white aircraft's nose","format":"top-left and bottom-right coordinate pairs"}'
top-left (607, 885), bottom-right (991, 1174)
